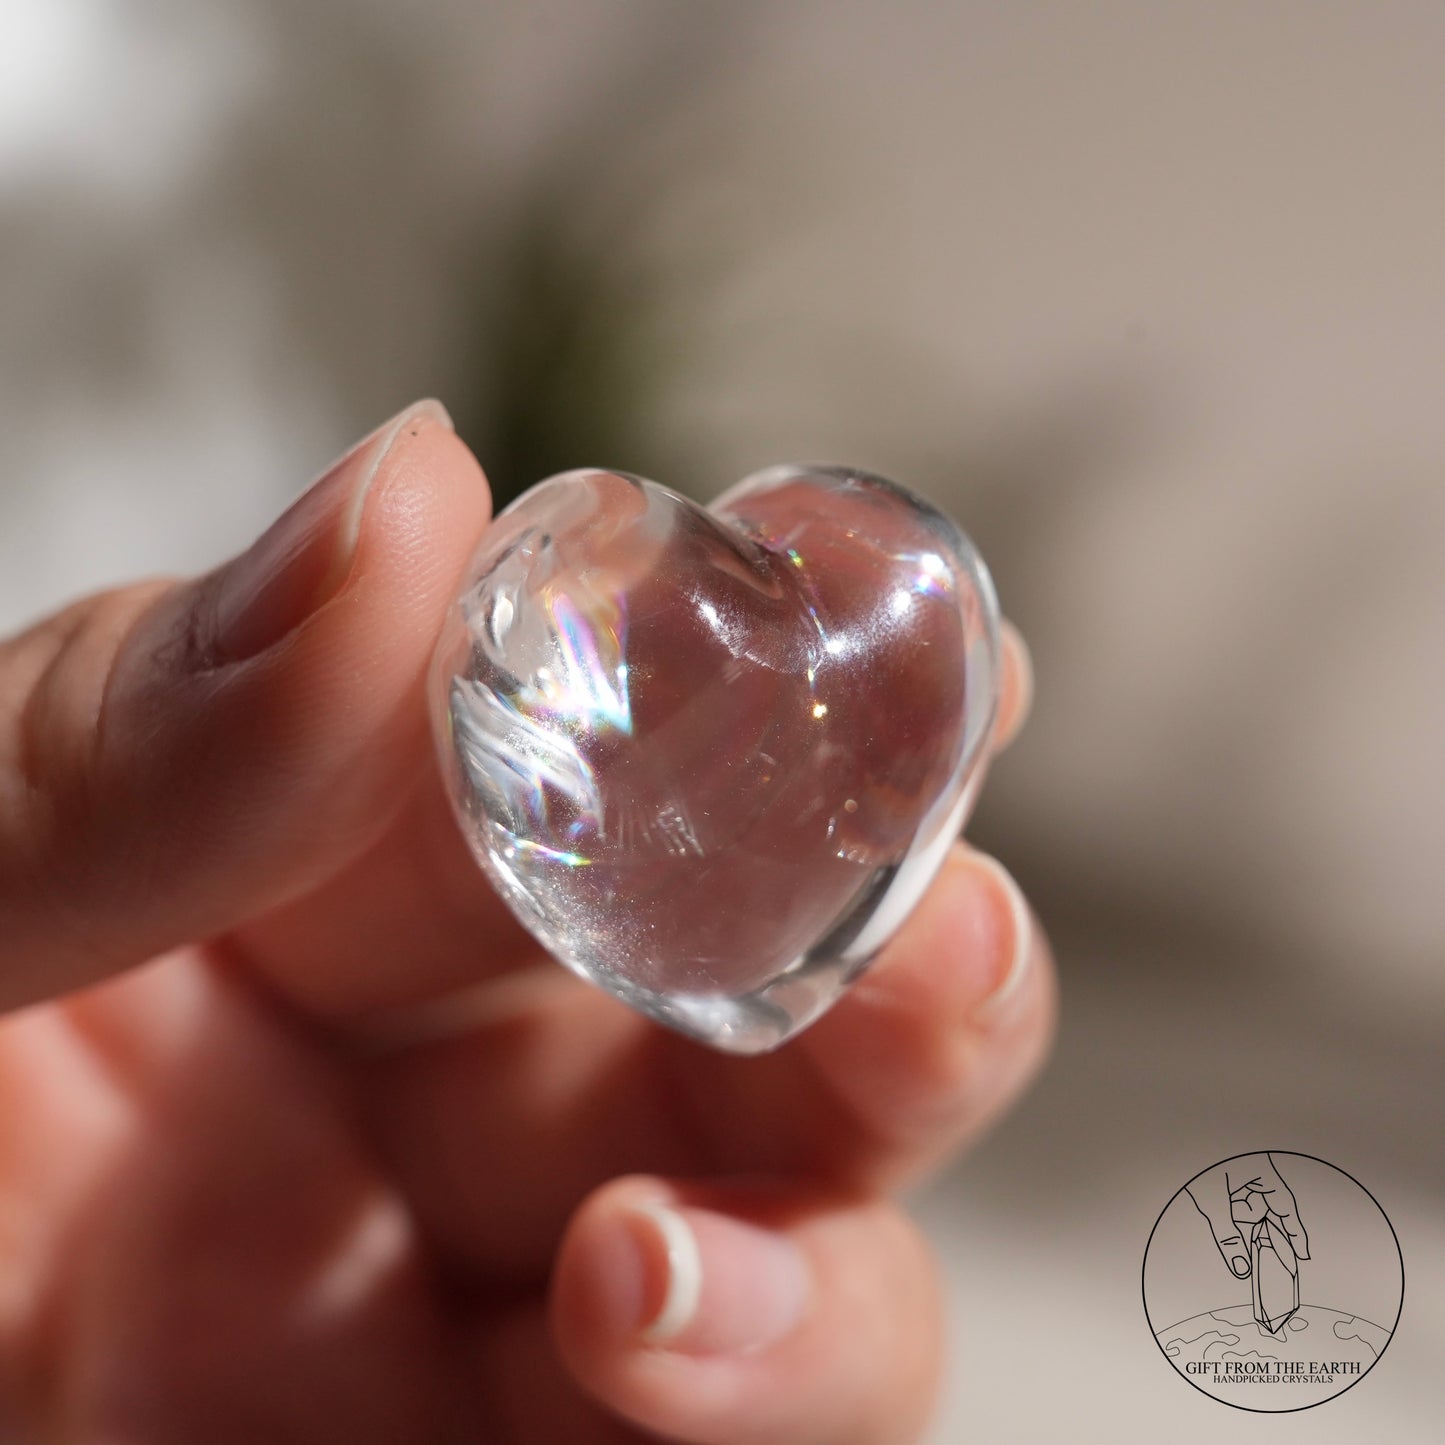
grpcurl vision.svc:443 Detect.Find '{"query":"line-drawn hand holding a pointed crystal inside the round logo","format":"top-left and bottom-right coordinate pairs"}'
top-left (1188, 1153), bottom-right (1309, 1335)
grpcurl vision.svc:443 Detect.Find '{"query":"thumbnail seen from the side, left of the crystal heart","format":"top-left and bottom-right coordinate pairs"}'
top-left (211, 400), bottom-right (452, 662)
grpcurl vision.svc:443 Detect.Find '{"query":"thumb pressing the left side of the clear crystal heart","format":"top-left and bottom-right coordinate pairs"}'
top-left (0, 402), bottom-right (490, 1009)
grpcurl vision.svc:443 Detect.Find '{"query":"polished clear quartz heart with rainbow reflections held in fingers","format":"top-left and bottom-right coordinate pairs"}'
top-left (431, 467), bottom-right (998, 1053)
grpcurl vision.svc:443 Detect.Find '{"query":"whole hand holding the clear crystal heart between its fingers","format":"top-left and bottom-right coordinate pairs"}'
top-left (0, 403), bottom-right (1053, 1445)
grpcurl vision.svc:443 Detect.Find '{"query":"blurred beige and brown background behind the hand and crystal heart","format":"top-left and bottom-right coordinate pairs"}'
top-left (0, 0), bottom-right (1445, 1442)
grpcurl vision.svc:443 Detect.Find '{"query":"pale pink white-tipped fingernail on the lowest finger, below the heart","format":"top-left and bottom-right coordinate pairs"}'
top-left (626, 1204), bottom-right (811, 1354)
